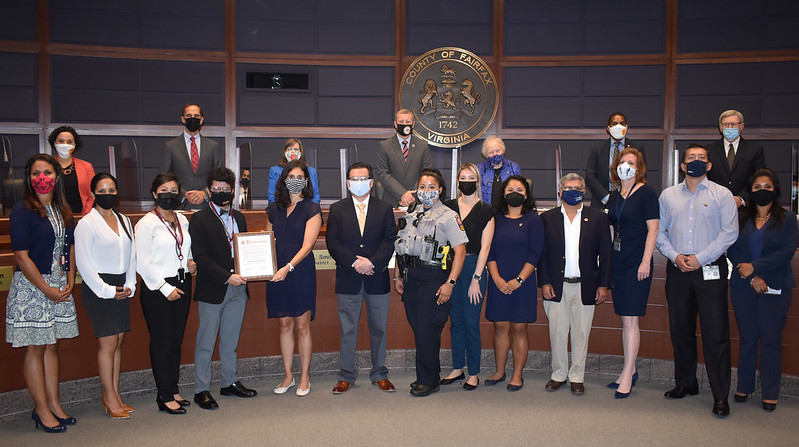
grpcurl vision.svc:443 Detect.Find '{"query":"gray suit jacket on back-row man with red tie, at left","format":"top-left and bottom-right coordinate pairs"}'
top-left (159, 133), bottom-right (225, 209)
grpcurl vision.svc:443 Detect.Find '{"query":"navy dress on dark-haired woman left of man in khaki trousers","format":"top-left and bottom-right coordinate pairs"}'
top-left (486, 210), bottom-right (544, 323)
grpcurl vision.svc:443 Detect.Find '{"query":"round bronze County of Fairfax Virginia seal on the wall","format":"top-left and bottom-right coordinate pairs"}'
top-left (398, 47), bottom-right (498, 148)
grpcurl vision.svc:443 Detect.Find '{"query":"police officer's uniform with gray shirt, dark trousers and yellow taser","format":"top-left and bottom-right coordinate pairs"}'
top-left (394, 201), bottom-right (469, 392)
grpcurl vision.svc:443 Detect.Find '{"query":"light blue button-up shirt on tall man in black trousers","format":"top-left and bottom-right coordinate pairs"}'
top-left (657, 177), bottom-right (738, 265)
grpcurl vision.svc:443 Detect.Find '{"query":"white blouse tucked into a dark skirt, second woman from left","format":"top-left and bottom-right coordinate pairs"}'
top-left (75, 208), bottom-right (136, 299)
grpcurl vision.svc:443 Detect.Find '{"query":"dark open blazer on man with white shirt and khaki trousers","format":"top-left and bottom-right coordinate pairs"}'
top-left (538, 206), bottom-right (612, 305)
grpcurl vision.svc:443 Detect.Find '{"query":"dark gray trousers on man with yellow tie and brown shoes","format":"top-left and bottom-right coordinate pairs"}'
top-left (336, 286), bottom-right (389, 383)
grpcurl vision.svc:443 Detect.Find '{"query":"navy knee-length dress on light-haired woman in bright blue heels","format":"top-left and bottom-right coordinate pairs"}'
top-left (608, 184), bottom-right (660, 317)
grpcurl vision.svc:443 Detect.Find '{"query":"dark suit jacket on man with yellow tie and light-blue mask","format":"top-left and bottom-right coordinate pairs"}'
top-left (325, 196), bottom-right (397, 295)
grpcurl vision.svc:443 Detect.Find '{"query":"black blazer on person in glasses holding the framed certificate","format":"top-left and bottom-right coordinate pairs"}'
top-left (189, 206), bottom-right (247, 304)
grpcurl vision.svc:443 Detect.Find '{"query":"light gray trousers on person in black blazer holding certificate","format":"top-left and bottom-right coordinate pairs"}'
top-left (194, 284), bottom-right (247, 394)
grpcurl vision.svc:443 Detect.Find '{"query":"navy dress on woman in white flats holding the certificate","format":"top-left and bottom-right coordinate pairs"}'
top-left (266, 199), bottom-right (322, 320)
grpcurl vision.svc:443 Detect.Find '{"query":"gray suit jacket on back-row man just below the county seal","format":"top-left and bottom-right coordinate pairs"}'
top-left (375, 135), bottom-right (433, 206)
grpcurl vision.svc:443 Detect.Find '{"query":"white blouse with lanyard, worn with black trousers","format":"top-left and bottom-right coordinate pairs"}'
top-left (136, 212), bottom-right (191, 297)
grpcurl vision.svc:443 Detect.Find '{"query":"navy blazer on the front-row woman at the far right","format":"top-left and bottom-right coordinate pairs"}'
top-left (727, 211), bottom-right (799, 293)
